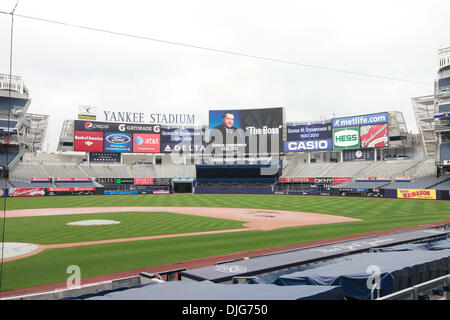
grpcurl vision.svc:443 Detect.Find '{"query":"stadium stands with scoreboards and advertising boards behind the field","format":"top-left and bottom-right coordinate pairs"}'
top-left (0, 48), bottom-right (450, 199)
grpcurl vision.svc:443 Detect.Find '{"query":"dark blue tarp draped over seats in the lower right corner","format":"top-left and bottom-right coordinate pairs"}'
top-left (274, 249), bottom-right (450, 300)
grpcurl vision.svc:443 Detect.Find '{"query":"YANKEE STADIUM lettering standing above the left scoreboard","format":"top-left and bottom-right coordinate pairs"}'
top-left (102, 110), bottom-right (195, 124)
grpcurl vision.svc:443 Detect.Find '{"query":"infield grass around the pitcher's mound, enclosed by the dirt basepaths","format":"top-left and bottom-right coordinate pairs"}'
top-left (0, 212), bottom-right (244, 244)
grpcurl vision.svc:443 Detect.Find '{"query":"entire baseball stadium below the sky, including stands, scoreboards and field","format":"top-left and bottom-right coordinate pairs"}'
top-left (0, 48), bottom-right (450, 300)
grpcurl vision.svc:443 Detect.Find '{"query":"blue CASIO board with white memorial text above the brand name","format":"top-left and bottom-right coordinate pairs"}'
top-left (284, 122), bottom-right (333, 152)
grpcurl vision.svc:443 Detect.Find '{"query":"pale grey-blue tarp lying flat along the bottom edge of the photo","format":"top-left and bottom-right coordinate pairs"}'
top-left (85, 281), bottom-right (344, 300)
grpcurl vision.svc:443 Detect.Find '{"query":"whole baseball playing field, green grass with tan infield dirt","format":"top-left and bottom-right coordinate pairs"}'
top-left (0, 194), bottom-right (450, 291)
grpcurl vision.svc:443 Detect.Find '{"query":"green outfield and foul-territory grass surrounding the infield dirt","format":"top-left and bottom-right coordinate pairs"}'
top-left (2, 194), bottom-right (450, 290)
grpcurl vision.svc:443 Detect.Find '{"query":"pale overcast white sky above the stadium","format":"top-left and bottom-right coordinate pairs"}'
top-left (0, 0), bottom-right (450, 152)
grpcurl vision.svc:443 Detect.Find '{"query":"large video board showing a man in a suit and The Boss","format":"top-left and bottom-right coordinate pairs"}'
top-left (206, 108), bottom-right (284, 155)
